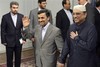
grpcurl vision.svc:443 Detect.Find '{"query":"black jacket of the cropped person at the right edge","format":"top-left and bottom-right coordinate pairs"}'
top-left (95, 9), bottom-right (100, 57)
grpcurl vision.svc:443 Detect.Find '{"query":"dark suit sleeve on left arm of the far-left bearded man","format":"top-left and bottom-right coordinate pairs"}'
top-left (1, 16), bottom-right (7, 44)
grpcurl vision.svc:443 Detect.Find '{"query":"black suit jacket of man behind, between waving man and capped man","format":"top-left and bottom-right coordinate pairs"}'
top-left (56, 9), bottom-right (72, 40)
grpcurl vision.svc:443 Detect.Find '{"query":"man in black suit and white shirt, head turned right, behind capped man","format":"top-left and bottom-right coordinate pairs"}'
top-left (56, 0), bottom-right (73, 40)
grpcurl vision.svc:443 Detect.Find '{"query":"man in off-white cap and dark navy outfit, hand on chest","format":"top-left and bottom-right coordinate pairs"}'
top-left (58, 5), bottom-right (97, 67)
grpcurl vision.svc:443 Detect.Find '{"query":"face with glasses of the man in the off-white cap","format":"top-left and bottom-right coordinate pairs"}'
top-left (73, 9), bottom-right (87, 24)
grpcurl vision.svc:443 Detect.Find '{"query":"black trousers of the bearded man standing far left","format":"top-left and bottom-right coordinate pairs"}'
top-left (6, 44), bottom-right (22, 67)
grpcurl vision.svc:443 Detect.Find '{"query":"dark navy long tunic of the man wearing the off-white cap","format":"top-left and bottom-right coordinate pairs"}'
top-left (60, 22), bottom-right (97, 67)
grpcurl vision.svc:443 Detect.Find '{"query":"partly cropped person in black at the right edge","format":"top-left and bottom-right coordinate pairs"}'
top-left (95, 1), bottom-right (100, 67)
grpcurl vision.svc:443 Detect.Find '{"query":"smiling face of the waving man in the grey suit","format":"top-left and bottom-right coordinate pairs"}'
top-left (38, 13), bottom-right (49, 27)
